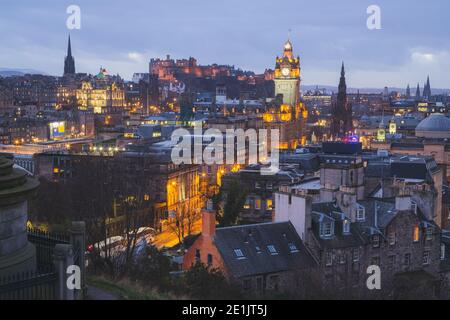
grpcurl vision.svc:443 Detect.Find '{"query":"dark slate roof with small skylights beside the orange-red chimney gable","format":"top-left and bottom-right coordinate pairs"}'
top-left (214, 222), bottom-right (316, 278)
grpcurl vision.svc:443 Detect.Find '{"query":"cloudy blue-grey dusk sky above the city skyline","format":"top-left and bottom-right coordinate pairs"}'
top-left (0, 0), bottom-right (450, 88)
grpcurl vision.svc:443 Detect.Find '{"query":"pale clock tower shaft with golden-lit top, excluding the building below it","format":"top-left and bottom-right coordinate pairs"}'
top-left (274, 40), bottom-right (300, 108)
